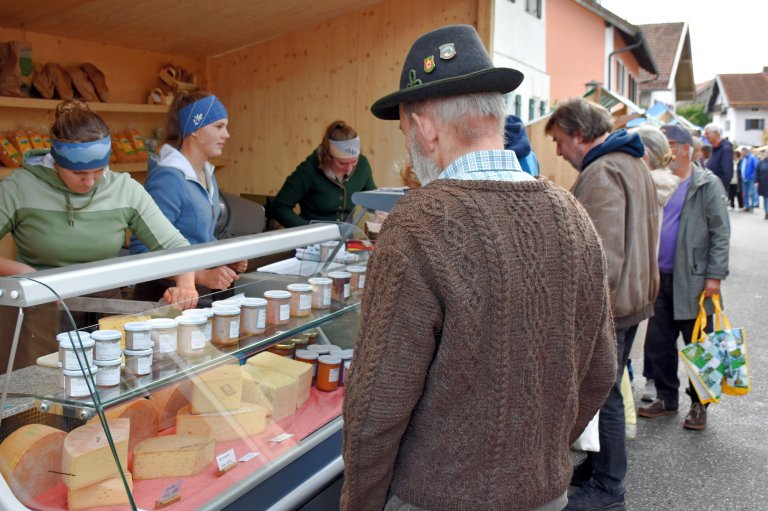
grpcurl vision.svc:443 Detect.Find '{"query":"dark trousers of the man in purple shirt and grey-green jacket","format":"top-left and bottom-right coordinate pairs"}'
top-left (644, 273), bottom-right (712, 407)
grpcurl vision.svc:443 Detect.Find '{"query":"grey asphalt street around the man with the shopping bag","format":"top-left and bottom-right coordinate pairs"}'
top-left (626, 209), bottom-right (768, 511)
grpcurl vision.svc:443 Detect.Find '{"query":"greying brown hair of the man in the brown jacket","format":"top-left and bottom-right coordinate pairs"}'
top-left (544, 98), bottom-right (613, 143)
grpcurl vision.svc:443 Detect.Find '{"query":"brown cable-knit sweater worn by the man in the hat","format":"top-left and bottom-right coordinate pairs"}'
top-left (342, 178), bottom-right (616, 511)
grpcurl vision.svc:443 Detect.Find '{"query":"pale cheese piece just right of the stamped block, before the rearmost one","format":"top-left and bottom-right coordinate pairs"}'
top-left (242, 366), bottom-right (298, 422)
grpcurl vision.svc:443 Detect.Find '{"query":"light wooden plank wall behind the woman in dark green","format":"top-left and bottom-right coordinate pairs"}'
top-left (209, 0), bottom-right (486, 195)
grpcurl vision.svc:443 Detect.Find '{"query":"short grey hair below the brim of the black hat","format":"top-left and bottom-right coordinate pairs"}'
top-left (405, 92), bottom-right (507, 144)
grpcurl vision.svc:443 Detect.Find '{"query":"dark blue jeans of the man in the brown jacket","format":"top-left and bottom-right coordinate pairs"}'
top-left (585, 325), bottom-right (637, 495)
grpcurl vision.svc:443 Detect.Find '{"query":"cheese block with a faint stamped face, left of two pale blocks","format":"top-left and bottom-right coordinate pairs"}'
top-left (189, 365), bottom-right (243, 413)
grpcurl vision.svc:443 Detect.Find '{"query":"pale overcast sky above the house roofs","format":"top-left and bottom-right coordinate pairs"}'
top-left (600, 0), bottom-right (768, 84)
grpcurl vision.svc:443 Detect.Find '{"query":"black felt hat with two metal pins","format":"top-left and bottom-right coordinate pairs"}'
top-left (371, 25), bottom-right (523, 120)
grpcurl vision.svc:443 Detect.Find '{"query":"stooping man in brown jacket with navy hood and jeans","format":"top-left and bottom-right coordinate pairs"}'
top-left (544, 98), bottom-right (659, 511)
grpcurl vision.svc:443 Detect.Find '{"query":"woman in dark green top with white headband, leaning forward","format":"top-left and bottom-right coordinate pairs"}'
top-left (271, 121), bottom-right (376, 227)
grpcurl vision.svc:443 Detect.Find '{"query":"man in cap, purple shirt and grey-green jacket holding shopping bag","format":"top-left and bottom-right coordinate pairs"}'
top-left (637, 125), bottom-right (730, 430)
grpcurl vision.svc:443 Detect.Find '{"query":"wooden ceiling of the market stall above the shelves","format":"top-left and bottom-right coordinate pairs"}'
top-left (0, 0), bottom-right (381, 57)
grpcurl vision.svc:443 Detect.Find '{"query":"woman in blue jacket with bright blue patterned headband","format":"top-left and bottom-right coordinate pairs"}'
top-left (131, 91), bottom-right (248, 301)
